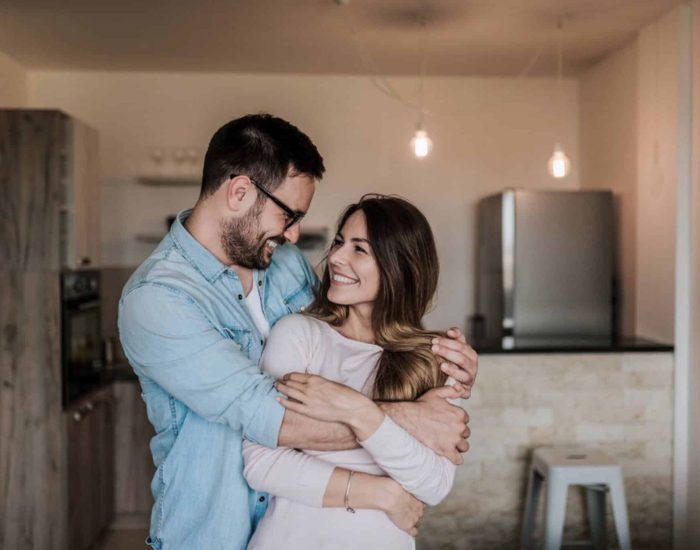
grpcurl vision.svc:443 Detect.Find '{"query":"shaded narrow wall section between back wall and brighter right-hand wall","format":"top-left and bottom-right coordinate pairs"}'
top-left (579, 41), bottom-right (637, 335)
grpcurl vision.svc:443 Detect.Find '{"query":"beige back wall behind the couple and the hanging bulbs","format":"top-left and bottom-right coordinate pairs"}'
top-left (24, 72), bottom-right (579, 327)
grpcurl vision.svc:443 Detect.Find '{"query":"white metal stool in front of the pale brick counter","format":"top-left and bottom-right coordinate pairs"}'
top-left (521, 447), bottom-right (630, 550)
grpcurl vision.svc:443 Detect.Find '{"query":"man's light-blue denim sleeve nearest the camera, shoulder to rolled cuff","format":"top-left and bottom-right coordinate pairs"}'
top-left (119, 283), bottom-right (284, 447)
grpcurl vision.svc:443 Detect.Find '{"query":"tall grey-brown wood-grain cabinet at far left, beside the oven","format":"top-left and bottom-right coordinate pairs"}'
top-left (0, 109), bottom-right (100, 550)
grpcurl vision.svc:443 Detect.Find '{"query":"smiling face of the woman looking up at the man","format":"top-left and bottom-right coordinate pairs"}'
top-left (327, 210), bottom-right (379, 312)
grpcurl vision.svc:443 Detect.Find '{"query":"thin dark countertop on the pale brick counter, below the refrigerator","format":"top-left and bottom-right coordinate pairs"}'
top-left (471, 337), bottom-right (673, 355)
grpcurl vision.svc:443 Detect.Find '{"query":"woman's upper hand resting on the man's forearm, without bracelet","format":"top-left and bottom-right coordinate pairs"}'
top-left (276, 372), bottom-right (384, 440)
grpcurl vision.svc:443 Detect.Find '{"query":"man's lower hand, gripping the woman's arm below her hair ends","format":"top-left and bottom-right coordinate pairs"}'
top-left (380, 385), bottom-right (470, 464)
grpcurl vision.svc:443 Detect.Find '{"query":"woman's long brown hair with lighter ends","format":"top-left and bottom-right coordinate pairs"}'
top-left (307, 194), bottom-right (447, 401)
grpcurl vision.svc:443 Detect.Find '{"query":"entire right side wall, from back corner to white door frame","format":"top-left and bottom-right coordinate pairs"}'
top-left (580, 9), bottom-right (679, 342)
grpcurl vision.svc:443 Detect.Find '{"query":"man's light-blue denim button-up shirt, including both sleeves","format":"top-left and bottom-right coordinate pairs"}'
top-left (119, 210), bottom-right (316, 550)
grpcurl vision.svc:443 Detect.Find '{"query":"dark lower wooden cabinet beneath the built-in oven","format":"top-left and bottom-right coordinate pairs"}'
top-left (64, 386), bottom-right (115, 550)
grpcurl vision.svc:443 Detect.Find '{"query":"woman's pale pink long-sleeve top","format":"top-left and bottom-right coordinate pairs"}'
top-left (243, 315), bottom-right (455, 550)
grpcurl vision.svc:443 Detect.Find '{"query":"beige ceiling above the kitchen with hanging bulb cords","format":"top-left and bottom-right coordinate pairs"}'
top-left (0, 0), bottom-right (682, 76)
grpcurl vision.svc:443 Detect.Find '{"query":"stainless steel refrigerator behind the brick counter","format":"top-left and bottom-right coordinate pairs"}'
top-left (477, 190), bottom-right (615, 344)
